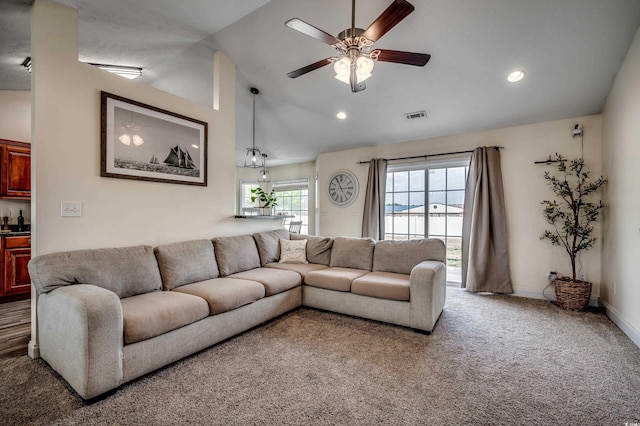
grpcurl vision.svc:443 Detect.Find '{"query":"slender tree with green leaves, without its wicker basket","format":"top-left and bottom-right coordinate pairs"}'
top-left (540, 154), bottom-right (606, 282)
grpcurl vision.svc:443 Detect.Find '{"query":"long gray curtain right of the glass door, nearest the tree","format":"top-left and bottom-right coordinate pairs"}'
top-left (462, 147), bottom-right (513, 293)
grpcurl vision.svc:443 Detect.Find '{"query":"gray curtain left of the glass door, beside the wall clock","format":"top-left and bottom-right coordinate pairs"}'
top-left (362, 158), bottom-right (387, 240)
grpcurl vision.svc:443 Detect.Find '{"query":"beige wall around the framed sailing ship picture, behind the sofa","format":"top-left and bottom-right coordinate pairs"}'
top-left (32, 0), bottom-right (270, 254)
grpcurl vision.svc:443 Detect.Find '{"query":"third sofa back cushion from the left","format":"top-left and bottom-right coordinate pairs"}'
top-left (213, 235), bottom-right (260, 277)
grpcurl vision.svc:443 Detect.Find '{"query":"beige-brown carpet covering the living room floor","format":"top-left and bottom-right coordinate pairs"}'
top-left (0, 288), bottom-right (640, 426)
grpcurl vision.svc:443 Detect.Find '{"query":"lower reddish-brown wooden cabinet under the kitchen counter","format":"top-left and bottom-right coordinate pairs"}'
top-left (0, 236), bottom-right (31, 302)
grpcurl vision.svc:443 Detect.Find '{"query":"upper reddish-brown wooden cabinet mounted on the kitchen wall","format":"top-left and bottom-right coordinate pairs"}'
top-left (0, 139), bottom-right (31, 199)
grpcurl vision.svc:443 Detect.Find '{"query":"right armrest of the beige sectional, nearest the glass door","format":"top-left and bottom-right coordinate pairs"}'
top-left (409, 260), bottom-right (447, 331)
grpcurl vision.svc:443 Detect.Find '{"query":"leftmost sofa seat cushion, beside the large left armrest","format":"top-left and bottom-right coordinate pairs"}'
top-left (120, 291), bottom-right (209, 344)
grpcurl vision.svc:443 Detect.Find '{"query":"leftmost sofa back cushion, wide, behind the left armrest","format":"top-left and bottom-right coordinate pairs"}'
top-left (29, 246), bottom-right (162, 299)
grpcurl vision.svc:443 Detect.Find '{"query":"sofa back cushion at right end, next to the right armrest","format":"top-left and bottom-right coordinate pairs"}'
top-left (373, 238), bottom-right (446, 274)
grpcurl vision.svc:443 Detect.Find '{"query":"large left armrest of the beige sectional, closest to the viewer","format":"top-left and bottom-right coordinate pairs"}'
top-left (38, 284), bottom-right (123, 399)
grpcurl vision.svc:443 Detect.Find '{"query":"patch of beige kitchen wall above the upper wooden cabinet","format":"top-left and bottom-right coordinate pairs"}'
top-left (0, 90), bottom-right (31, 142)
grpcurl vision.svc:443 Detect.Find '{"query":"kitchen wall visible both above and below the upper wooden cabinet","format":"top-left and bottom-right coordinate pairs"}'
top-left (0, 91), bottom-right (31, 224)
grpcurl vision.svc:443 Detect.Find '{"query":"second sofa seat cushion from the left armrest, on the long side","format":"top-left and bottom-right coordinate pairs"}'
top-left (173, 278), bottom-right (264, 315)
